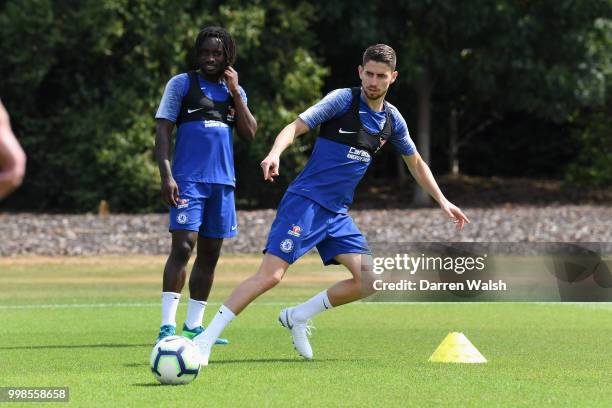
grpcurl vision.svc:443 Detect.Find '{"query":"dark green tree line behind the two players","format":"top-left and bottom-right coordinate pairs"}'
top-left (0, 0), bottom-right (612, 212)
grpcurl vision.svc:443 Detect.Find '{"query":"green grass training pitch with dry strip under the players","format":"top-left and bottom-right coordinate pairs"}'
top-left (0, 256), bottom-right (612, 407)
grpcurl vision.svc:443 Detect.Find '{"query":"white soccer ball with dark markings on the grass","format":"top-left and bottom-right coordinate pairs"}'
top-left (150, 336), bottom-right (200, 384)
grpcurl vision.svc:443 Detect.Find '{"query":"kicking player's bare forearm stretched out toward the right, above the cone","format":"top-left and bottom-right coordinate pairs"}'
top-left (402, 153), bottom-right (470, 229)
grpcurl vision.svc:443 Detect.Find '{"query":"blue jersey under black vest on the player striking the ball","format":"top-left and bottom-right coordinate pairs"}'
top-left (287, 88), bottom-right (416, 213)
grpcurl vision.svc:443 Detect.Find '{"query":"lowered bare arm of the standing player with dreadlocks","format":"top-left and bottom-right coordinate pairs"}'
top-left (155, 119), bottom-right (179, 207)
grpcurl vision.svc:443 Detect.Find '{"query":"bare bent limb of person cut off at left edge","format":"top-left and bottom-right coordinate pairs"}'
top-left (0, 102), bottom-right (26, 199)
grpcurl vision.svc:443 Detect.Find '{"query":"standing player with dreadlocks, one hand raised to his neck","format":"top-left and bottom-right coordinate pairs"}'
top-left (155, 27), bottom-right (257, 343)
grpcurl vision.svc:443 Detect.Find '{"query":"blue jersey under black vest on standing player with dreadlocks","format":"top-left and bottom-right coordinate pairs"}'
top-left (155, 73), bottom-right (247, 186)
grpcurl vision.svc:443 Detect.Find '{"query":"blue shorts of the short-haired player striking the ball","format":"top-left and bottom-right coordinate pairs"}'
top-left (264, 192), bottom-right (370, 265)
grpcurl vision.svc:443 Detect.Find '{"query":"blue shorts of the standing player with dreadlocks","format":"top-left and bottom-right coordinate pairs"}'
top-left (170, 181), bottom-right (238, 238)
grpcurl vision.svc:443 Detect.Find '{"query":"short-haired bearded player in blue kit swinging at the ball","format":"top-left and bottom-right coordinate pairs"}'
top-left (194, 44), bottom-right (469, 365)
